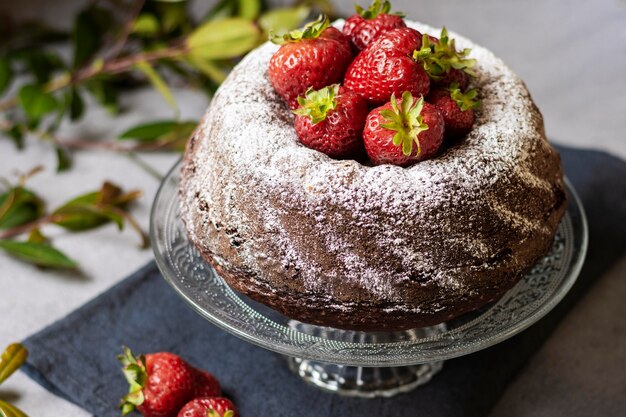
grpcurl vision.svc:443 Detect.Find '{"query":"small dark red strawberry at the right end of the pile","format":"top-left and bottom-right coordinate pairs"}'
top-left (427, 83), bottom-right (480, 139)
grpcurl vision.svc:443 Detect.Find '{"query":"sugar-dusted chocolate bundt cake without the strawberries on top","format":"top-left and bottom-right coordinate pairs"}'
top-left (180, 22), bottom-right (566, 331)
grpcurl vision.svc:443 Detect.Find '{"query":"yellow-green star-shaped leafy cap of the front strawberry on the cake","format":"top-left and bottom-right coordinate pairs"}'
top-left (380, 91), bottom-right (428, 156)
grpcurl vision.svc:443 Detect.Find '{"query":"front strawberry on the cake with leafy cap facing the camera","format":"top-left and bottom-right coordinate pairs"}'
top-left (363, 91), bottom-right (444, 166)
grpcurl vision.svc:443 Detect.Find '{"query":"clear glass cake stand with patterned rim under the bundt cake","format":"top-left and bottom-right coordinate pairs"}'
top-left (150, 163), bottom-right (587, 398)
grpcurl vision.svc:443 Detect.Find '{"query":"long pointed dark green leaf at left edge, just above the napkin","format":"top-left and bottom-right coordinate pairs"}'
top-left (0, 240), bottom-right (78, 269)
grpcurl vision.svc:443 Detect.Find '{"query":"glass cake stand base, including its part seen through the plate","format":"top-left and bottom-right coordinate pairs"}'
top-left (287, 320), bottom-right (446, 398)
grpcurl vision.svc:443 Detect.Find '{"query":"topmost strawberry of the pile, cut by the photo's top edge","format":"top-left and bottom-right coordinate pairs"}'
top-left (343, 0), bottom-right (406, 51)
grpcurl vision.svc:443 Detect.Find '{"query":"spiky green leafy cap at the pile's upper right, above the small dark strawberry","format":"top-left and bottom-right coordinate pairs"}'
top-left (413, 26), bottom-right (476, 80)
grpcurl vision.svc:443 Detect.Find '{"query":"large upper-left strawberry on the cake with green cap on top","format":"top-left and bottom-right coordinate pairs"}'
top-left (268, 15), bottom-right (352, 110)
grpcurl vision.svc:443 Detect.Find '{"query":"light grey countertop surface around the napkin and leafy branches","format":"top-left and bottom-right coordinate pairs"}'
top-left (0, 0), bottom-right (626, 417)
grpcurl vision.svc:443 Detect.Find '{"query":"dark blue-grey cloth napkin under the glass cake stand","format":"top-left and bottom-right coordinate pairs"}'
top-left (24, 148), bottom-right (626, 417)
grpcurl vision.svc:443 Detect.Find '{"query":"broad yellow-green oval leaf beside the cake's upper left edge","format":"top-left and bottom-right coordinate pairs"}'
top-left (187, 17), bottom-right (260, 59)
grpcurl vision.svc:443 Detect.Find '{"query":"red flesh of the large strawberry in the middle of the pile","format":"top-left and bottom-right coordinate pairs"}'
top-left (344, 28), bottom-right (430, 105)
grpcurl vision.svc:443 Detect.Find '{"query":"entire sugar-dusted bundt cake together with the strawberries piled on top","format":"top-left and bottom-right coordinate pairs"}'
top-left (180, 1), bottom-right (566, 331)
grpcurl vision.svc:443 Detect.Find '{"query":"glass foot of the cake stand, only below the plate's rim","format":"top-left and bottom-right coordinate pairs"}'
top-left (287, 357), bottom-right (443, 398)
